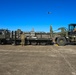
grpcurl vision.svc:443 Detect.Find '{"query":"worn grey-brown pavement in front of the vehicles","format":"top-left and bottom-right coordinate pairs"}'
top-left (0, 45), bottom-right (76, 75)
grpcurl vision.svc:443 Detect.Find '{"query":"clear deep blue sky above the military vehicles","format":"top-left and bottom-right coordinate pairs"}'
top-left (0, 0), bottom-right (76, 32)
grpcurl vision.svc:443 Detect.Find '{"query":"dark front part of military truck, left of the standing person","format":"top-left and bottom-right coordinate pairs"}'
top-left (0, 29), bottom-right (21, 45)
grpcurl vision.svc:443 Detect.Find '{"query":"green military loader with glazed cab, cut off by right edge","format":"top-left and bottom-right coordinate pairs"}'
top-left (55, 24), bottom-right (76, 46)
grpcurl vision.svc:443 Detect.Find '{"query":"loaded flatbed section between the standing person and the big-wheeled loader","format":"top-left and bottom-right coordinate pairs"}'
top-left (25, 31), bottom-right (52, 45)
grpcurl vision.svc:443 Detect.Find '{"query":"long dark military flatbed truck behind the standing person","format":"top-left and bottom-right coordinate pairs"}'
top-left (0, 29), bottom-right (52, 45)
